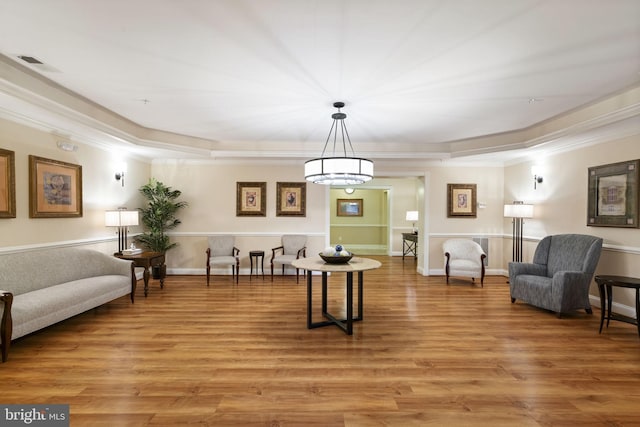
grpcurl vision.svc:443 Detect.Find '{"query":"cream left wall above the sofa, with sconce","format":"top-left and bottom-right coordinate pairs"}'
top-left (0, 119), bottom-right (150, 253)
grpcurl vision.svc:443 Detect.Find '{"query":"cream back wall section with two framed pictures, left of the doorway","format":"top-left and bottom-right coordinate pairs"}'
top-left (151, 160), bottom-right (329, 274)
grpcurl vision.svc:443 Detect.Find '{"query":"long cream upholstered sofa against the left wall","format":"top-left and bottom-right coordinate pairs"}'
top-left (0, 248), bottom-right (136, 362)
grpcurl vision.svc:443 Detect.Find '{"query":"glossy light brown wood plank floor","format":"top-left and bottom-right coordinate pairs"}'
top-left (0, 257), bottom-right (640, 427)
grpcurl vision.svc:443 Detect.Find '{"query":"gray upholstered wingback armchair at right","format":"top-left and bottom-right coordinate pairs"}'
top-left (509, 234), bottom-right (602, 317)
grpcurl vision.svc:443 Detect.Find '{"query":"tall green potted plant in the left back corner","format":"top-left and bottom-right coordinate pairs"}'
top-left (136, 178), bottom-right (187, 279)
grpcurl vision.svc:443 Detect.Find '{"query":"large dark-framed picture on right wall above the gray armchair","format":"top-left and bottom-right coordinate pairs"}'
top-left (587, 160), bottom-right (640, 228)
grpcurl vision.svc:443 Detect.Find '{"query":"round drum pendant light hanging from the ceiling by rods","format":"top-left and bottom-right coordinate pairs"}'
top-left (304, 102), bottom-right (373, 185)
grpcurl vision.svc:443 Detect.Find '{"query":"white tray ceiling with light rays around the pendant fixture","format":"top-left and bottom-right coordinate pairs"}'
top-left (0, 0), bottom-right (640, 167)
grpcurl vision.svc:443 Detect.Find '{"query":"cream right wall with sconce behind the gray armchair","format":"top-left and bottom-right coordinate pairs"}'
top-left (504, 136), bottom-right (640, 307)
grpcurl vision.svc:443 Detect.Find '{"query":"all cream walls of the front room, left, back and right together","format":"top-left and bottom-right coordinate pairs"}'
top-left (0, 115), bottom-right (640, 316)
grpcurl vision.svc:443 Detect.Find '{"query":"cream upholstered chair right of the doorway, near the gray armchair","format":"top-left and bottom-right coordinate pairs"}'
top-left (442, 239), bottom-right (487, 287)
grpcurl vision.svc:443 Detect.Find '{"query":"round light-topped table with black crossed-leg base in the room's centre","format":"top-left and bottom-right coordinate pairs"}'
top-left (291, 256), bottom-right (382, 335)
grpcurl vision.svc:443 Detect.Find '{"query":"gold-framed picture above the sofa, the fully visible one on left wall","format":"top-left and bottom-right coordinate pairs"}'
top-left (29, 156), bottom-right (82, 218)
